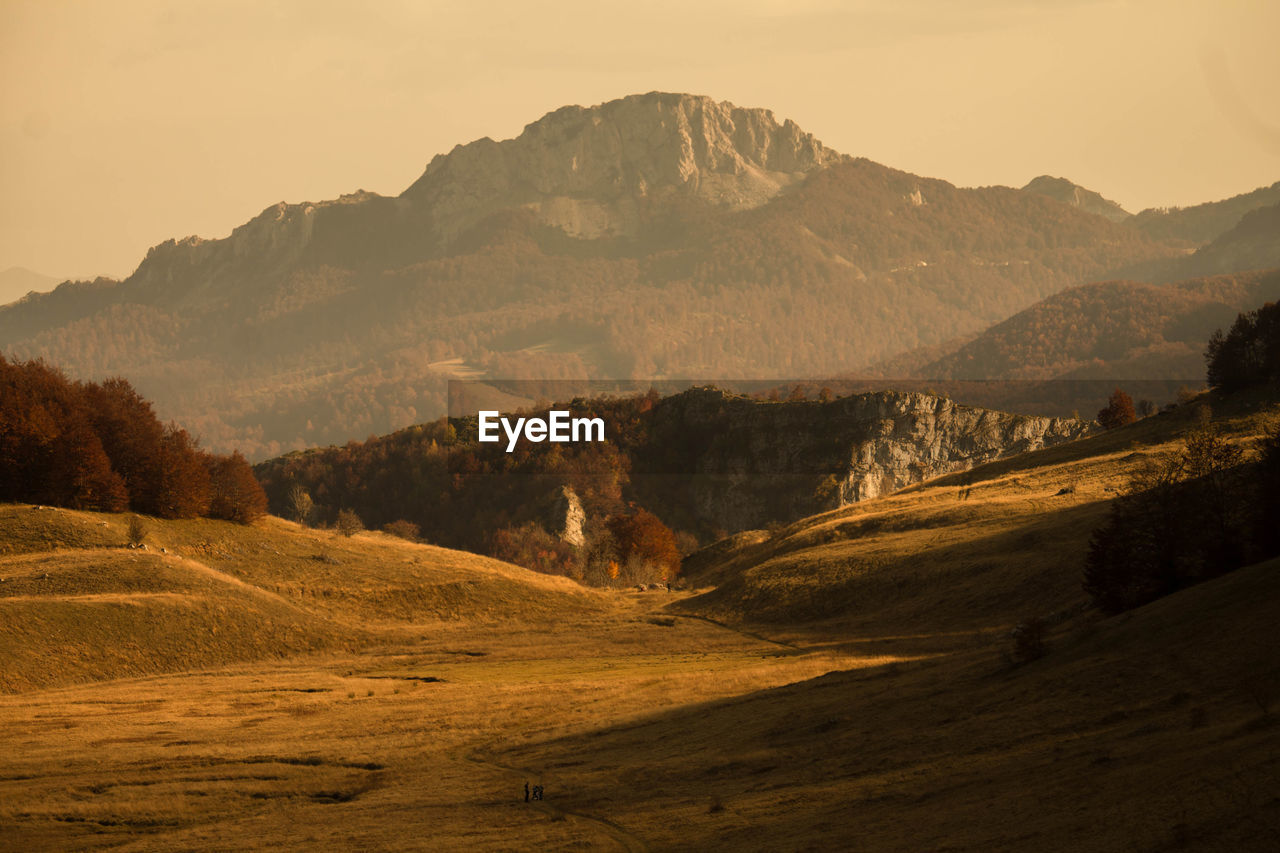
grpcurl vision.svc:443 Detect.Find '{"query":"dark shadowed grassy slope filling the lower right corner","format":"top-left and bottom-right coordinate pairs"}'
top-left (506, 548), bottom-right (1280, 853)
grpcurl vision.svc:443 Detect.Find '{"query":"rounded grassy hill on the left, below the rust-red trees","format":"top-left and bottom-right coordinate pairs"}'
top-left (0, 505), bottom-right (600, 692)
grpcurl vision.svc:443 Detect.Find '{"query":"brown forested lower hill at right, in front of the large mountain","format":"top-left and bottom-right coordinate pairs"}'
top-left (916, 270), bottom-right (1280, 379)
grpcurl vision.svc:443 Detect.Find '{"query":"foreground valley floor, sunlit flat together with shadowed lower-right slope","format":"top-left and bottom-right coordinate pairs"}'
top-left (0, 562), bottom-right (1280, 850)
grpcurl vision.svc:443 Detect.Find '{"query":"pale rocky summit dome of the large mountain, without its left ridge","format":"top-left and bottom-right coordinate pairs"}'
top-left (402, 92), bottom-right (841, 238)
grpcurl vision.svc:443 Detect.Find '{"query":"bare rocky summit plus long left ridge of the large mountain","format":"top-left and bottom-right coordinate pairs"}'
top-left (124, 92), bottom-right (845, 306)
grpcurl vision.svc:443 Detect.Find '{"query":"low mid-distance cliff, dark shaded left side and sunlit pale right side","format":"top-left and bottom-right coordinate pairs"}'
top-left (632, 389), bottom-right (1093, 533)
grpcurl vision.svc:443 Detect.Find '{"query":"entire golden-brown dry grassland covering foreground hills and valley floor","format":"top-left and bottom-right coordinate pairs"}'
top-left (0, 389), bottom-right (1280, 852)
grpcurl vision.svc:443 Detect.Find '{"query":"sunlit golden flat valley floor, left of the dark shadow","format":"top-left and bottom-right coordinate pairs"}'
top-left (0, 593), bottom-right (892, 850)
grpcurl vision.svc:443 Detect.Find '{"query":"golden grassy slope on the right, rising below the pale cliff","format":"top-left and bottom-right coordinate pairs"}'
top-left (680, 392), bottom-right (1280, 635)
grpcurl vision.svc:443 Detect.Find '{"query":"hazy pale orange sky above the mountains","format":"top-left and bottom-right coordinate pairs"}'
top-left (0, 0), bottom-right (1280, 277)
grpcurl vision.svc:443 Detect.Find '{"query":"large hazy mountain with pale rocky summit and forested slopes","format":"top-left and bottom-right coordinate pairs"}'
top-left (0, 93), bottom-right (1172, 459)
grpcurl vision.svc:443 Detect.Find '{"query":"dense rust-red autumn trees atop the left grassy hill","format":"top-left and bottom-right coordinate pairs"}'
top-left (0, 356), bottom-right (266, 524)
